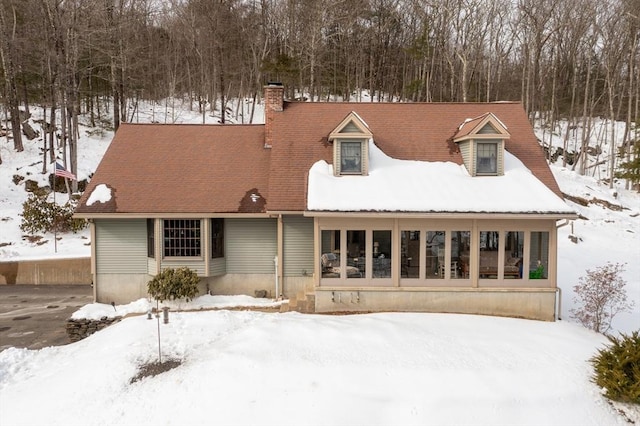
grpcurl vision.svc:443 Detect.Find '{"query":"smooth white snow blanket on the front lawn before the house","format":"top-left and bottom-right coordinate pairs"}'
top-left (0, 306), bottom-right (626, 426)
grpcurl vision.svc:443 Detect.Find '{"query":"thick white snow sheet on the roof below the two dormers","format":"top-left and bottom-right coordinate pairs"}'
top-left (307, 139), bottom-right (574, 214)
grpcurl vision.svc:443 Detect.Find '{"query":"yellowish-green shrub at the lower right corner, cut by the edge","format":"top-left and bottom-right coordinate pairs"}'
top-left (590, 331), bottom-right (640, 404)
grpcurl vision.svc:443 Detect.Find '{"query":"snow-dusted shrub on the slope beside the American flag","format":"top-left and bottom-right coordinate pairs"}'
top-left (20, 193), bottom-right (87, 235)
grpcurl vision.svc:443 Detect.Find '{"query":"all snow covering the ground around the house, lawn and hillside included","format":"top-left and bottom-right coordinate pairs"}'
top-left (0, 100), bottom-right (640, 425)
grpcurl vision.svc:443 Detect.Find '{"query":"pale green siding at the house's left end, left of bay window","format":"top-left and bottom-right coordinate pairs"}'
top-left (95, 219), bottom-right (147, 274)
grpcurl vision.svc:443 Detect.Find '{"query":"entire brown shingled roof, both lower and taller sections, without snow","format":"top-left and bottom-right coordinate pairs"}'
top-left (76, 102), bottom-right (562, 215)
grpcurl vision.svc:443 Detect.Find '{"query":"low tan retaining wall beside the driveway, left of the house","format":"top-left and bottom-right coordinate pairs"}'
top-left (0, 257), bottom-right (93, 285)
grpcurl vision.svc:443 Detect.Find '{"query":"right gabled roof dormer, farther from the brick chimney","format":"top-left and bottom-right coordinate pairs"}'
top-left (453, 112), bottom-right (511, 176)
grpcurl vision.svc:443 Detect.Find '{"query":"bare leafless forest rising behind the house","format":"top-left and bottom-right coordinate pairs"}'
top-left (0, 0), bottom-right (640, 189)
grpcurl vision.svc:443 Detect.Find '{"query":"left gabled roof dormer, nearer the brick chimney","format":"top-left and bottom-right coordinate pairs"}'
top-left (329, 111), bottom-right (373, 176)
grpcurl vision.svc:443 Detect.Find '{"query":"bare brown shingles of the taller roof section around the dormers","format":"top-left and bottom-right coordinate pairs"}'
top-left (269, 102), bottom-right (561, 211)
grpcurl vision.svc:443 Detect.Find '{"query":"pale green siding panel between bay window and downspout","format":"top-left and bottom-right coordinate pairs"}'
top-left (225, 219), bottom-right (277, 274)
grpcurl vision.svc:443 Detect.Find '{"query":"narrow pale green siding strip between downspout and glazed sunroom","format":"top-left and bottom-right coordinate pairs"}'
top-left (283, 216), bottom-right (313, 277)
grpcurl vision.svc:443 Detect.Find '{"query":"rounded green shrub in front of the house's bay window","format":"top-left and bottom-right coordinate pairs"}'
top-left (147, 267), bottom-right (200, 302)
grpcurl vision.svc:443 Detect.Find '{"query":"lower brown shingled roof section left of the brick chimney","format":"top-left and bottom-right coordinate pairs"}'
top-left (76, 124), bottom-right (271, 214)
